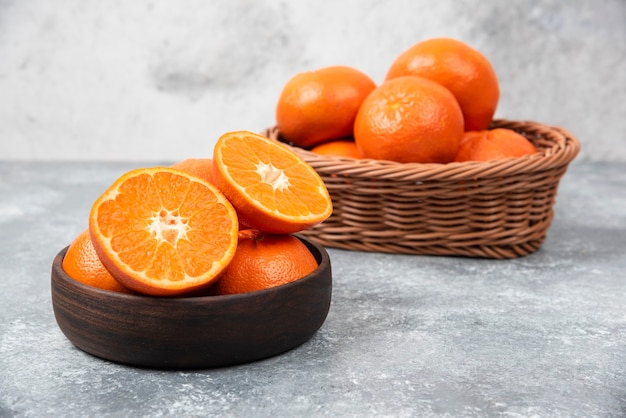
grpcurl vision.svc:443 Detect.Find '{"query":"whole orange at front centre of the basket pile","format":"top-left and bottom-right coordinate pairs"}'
top-left (354, 76), bottom-right (463, 163)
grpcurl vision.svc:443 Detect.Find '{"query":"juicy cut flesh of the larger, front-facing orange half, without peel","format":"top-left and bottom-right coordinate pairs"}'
top-left (98, 172), bottom-right (233, 281)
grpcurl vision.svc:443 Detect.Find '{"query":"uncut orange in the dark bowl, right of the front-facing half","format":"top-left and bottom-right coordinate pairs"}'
top-left (213, 230), bottom-right (318, 295)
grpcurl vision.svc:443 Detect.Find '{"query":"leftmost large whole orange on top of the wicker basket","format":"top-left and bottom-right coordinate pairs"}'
top-left (276, 66), bottom-right (376, 148)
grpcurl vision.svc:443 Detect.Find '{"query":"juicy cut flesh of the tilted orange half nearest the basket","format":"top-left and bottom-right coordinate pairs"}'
top-left (222, 137), bottom-right (328, 218)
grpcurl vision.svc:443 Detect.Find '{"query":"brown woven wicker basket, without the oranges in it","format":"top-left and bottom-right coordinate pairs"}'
top-left (264, 119), bottom-right (580, 259)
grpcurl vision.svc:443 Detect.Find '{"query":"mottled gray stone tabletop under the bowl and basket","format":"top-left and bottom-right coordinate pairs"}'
top-left (0, 161), bottom-right (626, 417)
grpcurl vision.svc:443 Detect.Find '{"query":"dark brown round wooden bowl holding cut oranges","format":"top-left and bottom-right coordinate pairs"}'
top-left (51, 236), bottom-right (332, 369)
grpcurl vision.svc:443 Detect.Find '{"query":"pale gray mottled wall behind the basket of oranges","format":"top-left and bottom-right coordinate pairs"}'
top-left (0, 0), bottom-right (626, 161)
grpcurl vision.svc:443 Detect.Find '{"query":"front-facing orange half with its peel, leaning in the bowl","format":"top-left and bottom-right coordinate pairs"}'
top-left (89, 167), bottom-right (239, 296)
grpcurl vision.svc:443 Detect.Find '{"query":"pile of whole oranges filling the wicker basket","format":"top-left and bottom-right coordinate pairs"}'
top-left (276, 38), bottom-right (537, 164)
